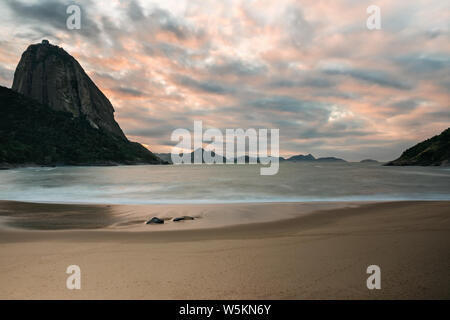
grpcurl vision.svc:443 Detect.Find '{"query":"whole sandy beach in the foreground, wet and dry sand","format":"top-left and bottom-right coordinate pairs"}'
top-left (0, 201), bottom-right (450, 299)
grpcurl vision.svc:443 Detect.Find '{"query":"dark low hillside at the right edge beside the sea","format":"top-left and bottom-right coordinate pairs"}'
top-left (386, 128), bottom-right (450, 166)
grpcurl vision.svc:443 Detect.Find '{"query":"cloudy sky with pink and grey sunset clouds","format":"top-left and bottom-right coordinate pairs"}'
top-left (0, 0), bottom-right (450, 161)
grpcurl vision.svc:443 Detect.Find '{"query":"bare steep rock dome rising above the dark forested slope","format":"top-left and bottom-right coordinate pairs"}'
top-left (12, 41), bottom-right (126, 139)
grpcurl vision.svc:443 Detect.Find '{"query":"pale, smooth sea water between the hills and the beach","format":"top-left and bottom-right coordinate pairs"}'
top-left (0, 162), bottom-right (450, 204)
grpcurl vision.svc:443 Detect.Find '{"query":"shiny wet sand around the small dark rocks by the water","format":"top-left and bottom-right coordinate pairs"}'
top-left (0, 200), bottom-right (363, 231)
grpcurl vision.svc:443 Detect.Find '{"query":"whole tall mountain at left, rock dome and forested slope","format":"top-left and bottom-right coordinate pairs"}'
top-left (0, 40), bottom-right (166, 167)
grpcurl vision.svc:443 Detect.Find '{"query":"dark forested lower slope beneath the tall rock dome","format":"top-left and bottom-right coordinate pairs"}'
top-left (0, 86), bottom-right (162, 168)
